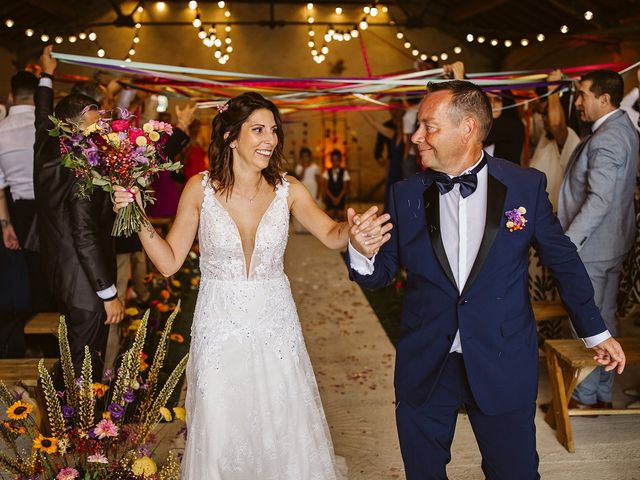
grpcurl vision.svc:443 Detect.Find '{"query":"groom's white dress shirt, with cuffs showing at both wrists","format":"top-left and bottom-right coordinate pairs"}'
top-left (349, 152), bottom-right (611, 353)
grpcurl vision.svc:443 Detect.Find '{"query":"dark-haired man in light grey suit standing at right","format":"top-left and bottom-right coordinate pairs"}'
top-left (558, 70), bottom-right (638, 408)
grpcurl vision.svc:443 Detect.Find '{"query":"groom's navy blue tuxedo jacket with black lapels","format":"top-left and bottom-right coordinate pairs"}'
top-left (350, 153), bottom-right (606, 415)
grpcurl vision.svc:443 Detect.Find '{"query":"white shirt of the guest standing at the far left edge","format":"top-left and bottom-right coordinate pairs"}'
top-left (0, 105), bottom-right (36, 200)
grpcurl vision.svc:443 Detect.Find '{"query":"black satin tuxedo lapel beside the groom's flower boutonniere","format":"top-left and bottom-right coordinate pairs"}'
top-left (462, 169), bottom-right (507, 296)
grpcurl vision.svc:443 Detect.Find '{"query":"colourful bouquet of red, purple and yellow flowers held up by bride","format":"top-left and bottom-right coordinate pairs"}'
top-left (49, 107), bottom-right (181, 237)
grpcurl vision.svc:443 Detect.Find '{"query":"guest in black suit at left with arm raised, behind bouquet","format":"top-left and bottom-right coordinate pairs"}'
top-left (34, 47), bottom-right (124, 379)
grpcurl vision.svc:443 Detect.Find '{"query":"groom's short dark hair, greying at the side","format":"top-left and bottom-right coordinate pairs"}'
top-left (427, 80), bottom-right (493, 142)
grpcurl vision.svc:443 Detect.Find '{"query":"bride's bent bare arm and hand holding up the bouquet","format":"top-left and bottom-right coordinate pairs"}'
top-left (113, 175), bottom-right (204, 277)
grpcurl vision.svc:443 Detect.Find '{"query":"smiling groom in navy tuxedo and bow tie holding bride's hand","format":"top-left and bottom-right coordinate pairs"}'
top-left (349, 80), bottom-right (625, 480)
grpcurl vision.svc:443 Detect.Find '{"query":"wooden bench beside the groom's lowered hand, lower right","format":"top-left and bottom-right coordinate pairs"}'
top-left (545, 337), bottom-right (640, 452)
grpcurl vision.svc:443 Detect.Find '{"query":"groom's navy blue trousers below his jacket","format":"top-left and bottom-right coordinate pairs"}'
top-left (396, 353), bottom-right (540, 480)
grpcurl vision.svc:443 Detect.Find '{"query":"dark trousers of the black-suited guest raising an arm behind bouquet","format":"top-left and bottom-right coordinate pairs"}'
top-left (55, 306), bottom-right (109, 389)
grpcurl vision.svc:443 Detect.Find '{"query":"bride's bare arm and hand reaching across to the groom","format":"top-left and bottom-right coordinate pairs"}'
top-left (287, 177), bottom-right (391, 250)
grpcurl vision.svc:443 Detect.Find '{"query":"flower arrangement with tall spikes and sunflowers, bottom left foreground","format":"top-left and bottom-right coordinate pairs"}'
top-left (0, 303), bottom-right (188, 480)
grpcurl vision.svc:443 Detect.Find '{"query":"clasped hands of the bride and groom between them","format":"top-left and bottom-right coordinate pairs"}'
top-left (347, 206), bottom-right (393, 258)
